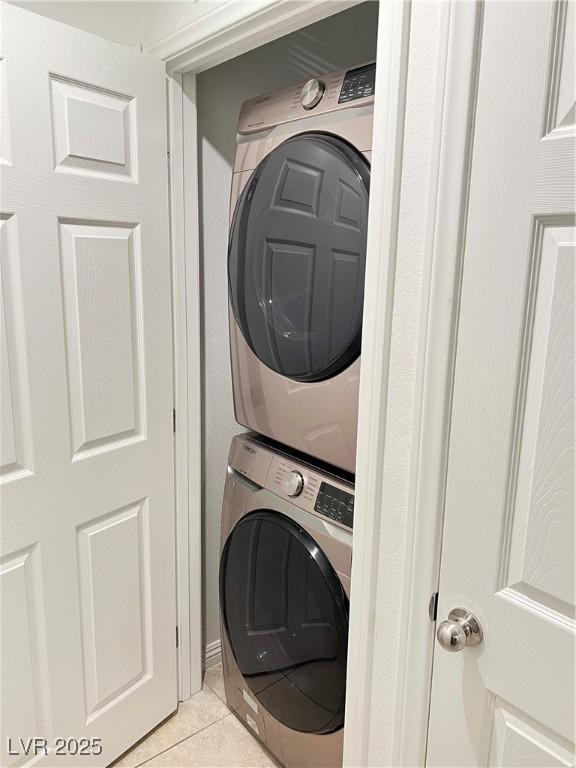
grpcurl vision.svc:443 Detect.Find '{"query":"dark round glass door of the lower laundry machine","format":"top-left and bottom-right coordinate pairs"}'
top-left (220, 510), bottom-right (348, 733)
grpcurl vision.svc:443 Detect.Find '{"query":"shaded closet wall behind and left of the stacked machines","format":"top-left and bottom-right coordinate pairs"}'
top-left (198, 2), bottom-right (378, 656)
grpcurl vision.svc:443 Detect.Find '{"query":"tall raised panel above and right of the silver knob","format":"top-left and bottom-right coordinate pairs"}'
top-left (506, 226), bottom-right (576, 618)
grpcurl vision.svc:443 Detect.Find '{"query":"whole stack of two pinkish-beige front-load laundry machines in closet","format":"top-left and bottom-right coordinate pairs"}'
top-left (220, 63), bottom-right (375, 768)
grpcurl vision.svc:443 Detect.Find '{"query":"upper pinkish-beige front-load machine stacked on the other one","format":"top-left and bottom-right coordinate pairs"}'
top-left (228, 63), bottom-right (375, 472)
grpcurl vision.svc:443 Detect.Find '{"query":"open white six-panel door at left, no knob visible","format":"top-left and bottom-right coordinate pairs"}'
top-left (0, 4), bottom-right (176, 766)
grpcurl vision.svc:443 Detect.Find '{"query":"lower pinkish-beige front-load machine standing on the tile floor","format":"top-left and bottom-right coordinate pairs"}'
top-left (220, 434), bottom-right (354, 768)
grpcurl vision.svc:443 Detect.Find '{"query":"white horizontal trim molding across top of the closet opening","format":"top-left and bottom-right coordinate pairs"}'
top-left (151, 0), bottom-right (361, 74)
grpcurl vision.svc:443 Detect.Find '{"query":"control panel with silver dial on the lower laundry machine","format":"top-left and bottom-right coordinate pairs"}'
top-left (229, 435), bottom-right (354, 528)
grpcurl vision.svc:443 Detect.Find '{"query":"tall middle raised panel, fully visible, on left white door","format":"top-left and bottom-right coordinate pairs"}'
top-left (60, 222), bottom-right (143, 456)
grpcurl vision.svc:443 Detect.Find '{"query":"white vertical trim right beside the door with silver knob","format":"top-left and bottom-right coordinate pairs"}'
top-left (396, 2), bottom-right (482, 766)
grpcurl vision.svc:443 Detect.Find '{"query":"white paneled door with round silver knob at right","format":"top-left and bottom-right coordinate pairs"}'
top-left (428, 2), bottom-right (576, 768)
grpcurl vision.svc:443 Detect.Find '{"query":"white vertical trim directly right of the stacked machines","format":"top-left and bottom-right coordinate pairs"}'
top-left (344, 2), bottom-right (411, 766)
